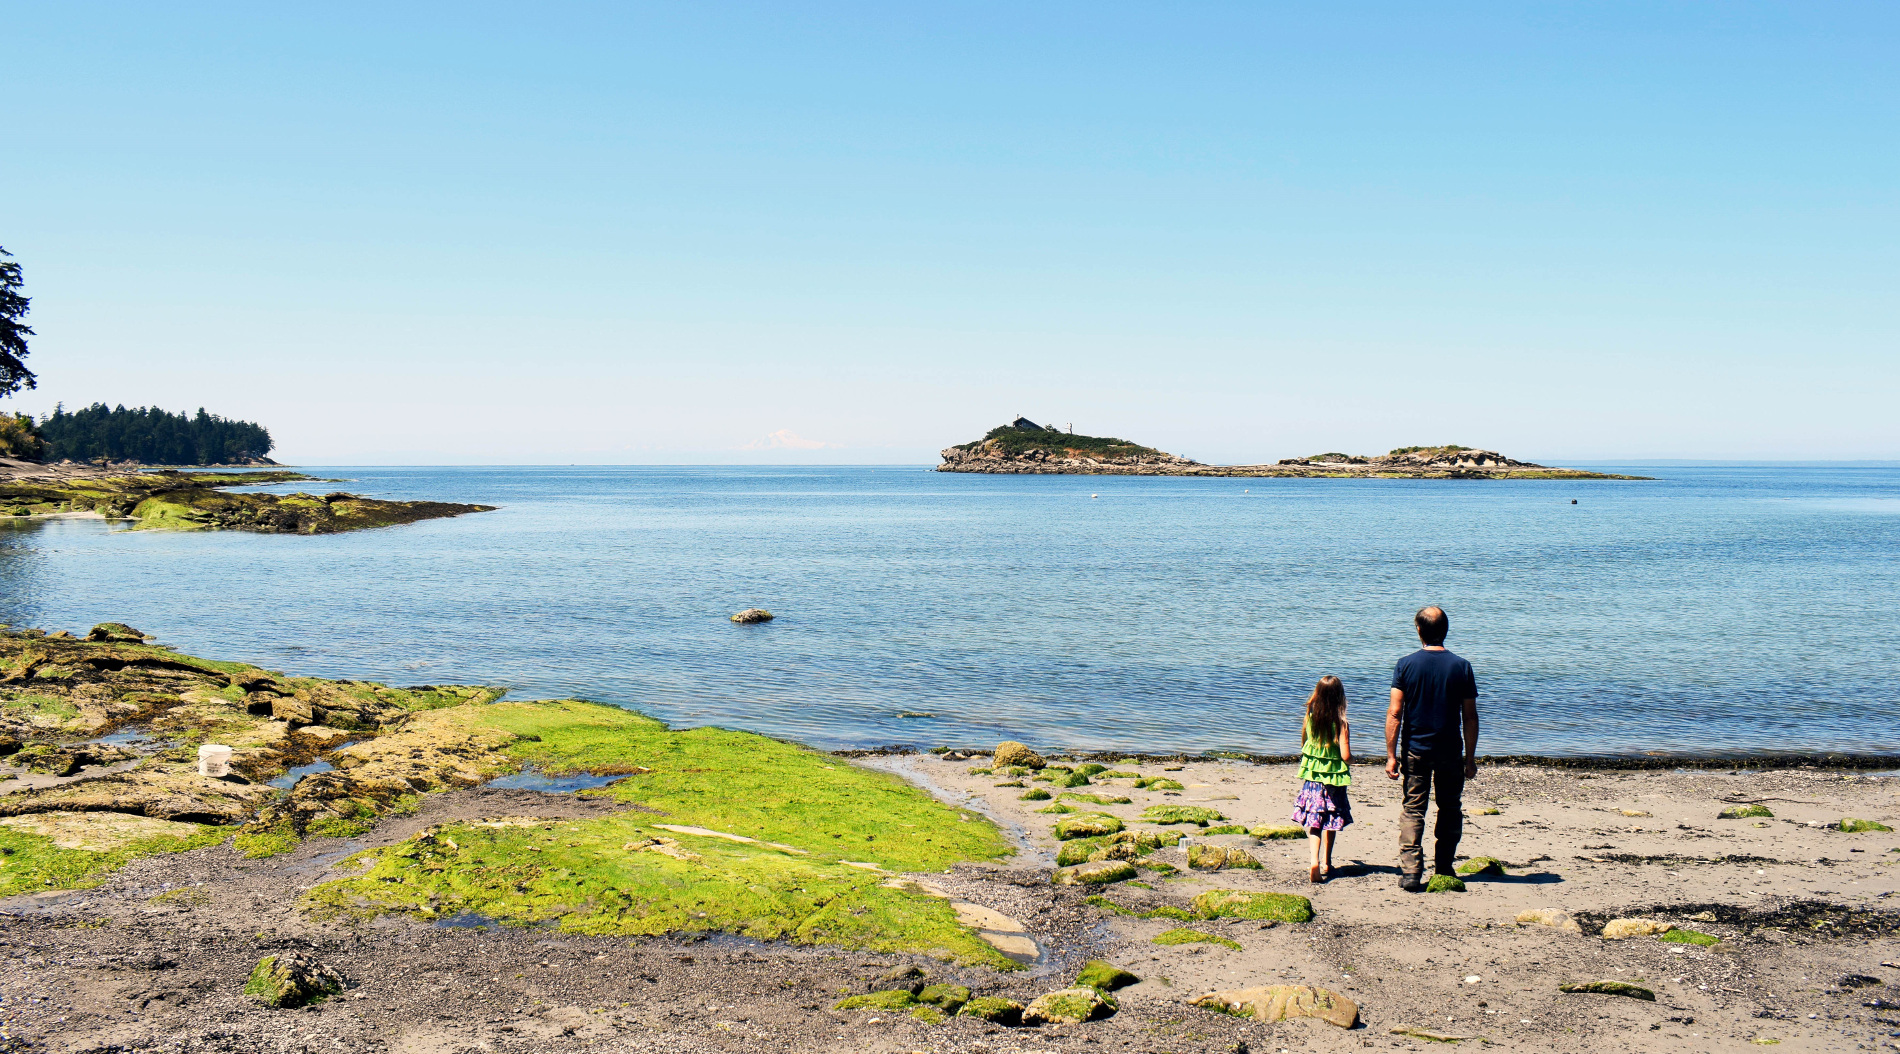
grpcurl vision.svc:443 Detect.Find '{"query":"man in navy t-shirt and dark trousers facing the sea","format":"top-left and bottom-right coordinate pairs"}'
top-left (1385, 606), bottom-right (1478, 893)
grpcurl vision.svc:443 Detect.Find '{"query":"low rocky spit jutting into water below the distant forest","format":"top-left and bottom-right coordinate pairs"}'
top-left (0, 461), bottom-right (494, 534)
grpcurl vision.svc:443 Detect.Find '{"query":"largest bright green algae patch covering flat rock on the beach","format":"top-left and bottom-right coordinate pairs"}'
top-left (306, 701), bottom-right (1020, 970)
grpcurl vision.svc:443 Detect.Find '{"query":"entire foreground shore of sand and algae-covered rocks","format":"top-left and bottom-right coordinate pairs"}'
top-left (0, 623), bottom-right (1900, 1052)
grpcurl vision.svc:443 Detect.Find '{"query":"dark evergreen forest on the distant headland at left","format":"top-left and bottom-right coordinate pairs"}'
top-left (38, 403), bottom-right (272, 465)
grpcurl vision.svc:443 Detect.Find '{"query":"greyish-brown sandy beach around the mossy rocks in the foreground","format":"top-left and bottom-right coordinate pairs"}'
top-left (0, 754), bottom-right (1900, 1054)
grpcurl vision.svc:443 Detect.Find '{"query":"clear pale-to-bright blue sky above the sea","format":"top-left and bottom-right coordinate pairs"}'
top-left (0, 2), bottom-right (1900, 463)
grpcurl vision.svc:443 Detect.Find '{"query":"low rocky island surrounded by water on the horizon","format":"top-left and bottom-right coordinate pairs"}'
top-left (937, 418), bottom-right (1649, 479)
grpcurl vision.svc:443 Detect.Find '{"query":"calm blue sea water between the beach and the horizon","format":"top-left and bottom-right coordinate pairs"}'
top-left (0, 467), bottom-right (1900, 754)
